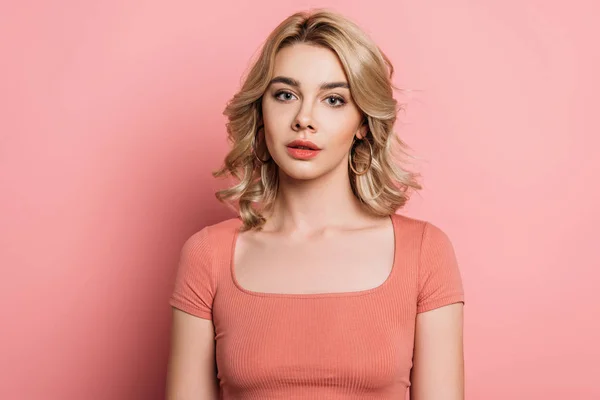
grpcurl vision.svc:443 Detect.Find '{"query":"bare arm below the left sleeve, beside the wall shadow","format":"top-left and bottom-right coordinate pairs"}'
top-left (166, 308), bottom-right (219, 400)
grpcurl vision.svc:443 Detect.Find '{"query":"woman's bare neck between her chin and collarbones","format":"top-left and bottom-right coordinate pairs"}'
top-left (265, 163), bottom-right (368, 234)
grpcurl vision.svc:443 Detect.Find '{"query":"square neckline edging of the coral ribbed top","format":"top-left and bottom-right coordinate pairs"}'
top-left (229, 214), bottom-right (399, 299)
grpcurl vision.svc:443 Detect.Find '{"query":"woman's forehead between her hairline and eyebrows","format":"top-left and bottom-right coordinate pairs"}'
top-left (274, 43), bottom-right (347, 87)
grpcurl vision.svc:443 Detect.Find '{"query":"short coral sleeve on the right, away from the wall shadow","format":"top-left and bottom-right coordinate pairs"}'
top-left (417, 222), bottom-right (464, 313)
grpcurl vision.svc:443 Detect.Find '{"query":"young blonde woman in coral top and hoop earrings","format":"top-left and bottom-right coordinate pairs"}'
top-left (167, 10), bottom-right (464, 400)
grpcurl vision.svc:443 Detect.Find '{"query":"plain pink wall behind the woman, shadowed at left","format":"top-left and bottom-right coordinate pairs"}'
top-left (0, 0), bottom-right (600, 400)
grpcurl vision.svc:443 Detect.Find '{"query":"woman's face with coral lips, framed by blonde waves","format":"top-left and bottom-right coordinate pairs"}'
top-left (262, 44), bottom-right (366, 180)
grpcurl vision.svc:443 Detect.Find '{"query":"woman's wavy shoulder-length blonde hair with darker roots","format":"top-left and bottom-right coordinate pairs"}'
top-left (213, 9), bottom-right (421, 230)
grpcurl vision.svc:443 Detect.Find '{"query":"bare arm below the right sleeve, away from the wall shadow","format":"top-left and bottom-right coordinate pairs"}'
top-left (410, 303), bottom-right (465, 400)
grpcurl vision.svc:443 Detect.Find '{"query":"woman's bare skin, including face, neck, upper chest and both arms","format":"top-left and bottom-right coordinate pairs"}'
top-left (167, 44), bottom-right (464, 400)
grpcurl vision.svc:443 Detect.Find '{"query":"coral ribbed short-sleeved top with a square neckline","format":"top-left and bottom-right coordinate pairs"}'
top-left (170, 215), bottom-right (464, 400)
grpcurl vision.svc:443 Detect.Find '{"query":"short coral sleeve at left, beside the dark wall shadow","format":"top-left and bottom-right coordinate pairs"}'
top-left (169, 228), bottom-right (215, 319)
